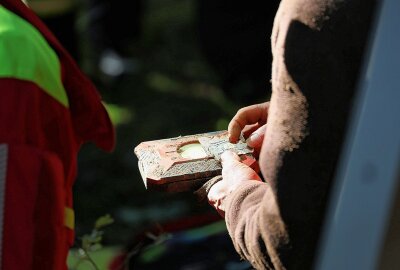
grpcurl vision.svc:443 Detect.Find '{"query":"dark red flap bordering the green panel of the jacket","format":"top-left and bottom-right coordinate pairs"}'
top-left (0, 0), bottom-right (115, 151)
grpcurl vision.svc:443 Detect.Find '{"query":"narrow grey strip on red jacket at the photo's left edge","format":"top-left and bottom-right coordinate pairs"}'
top-left (0, 144), bottom-right (8, 269)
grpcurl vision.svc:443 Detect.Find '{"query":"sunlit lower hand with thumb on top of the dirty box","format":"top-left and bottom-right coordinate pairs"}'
top-left (207, 151), bottom-right (261, 216)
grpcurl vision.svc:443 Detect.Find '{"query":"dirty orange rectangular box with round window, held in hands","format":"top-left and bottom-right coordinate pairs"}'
top-left (135, 131), bottom-right (258, 192)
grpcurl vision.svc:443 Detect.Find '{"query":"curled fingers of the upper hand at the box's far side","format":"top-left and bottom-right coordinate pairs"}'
top-left (228, 102), bottom-right (269, 152)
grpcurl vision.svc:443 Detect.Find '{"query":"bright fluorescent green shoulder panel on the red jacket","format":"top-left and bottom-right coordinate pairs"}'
top-left (0, 5), bottom-right (68, 107)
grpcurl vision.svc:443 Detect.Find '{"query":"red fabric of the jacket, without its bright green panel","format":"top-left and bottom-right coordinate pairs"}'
top-left (0, 0), bottom-right (115, 270)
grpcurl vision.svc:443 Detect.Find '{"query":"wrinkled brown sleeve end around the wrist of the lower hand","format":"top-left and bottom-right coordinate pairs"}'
top-left (225, 180), bottom-right (288, 269)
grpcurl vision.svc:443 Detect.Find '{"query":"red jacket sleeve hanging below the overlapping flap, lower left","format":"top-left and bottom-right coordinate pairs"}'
top-left (2, 144), bottom-right (67, 270)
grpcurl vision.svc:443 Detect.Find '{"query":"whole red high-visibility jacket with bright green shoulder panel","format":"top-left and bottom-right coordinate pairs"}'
top-left (0, 0), bottom-right (114, 270)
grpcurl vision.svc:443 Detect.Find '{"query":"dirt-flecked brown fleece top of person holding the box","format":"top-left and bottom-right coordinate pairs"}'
top-left (226, 0), bottom-right (375, 269)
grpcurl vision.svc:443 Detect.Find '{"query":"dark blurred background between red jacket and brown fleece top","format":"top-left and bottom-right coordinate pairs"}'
top-left (29, 0), bottom-right (279, 269)
